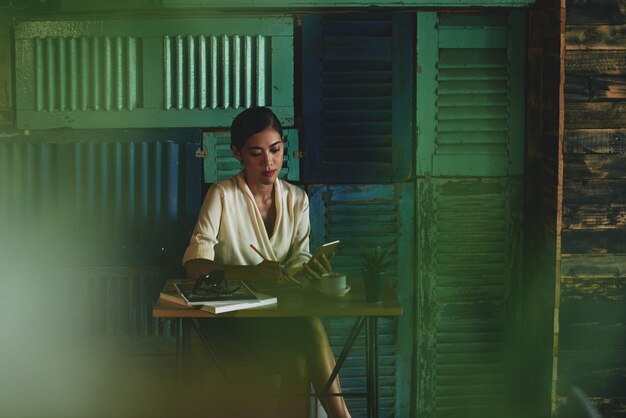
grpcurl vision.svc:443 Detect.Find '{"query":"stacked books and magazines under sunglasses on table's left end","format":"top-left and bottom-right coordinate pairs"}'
top-left (160, 280), bottom-right (278, 314)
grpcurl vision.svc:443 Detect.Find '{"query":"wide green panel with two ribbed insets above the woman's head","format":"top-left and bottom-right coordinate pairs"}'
top-left (15, 16), bottom-right (294, 128)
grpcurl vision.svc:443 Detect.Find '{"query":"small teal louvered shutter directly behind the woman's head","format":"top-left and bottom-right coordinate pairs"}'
top-left (202, 129), bottom-right (300, 183)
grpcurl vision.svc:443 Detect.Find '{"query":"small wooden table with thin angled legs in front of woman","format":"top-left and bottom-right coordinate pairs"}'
top-left (152, 278), bottom-right (402, 417)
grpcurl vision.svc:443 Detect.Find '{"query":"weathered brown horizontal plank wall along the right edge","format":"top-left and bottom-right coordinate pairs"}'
top-left (557, 0), bottom-right (626, 417)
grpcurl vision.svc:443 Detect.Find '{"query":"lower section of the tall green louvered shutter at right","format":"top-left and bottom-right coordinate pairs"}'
top-left (418, 178), bottom-right (522, 418)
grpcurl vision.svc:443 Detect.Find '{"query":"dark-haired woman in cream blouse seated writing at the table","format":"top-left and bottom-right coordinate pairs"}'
top-left (183, 107), bottom-right (350, 417)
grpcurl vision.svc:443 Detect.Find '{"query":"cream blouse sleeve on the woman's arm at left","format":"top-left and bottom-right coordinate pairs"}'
top-left (183, 184), bottom-right (224, 265)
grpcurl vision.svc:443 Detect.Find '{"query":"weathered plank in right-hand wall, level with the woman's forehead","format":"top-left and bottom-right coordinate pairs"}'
top-left (563, 129), bottom-right (626, 154)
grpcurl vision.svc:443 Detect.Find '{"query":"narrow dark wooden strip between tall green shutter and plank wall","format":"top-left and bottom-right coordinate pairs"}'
top-left (517, 0), bottom-right (563, 417)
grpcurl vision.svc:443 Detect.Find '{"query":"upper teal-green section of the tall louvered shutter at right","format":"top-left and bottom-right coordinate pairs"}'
top-left (417, 12), bottom-right (524, 176)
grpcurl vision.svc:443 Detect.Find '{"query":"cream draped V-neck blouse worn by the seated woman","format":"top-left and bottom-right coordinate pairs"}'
top-left (183, 172), bottom-right (311, 275)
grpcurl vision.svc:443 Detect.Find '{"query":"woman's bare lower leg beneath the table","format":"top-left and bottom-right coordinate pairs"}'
top-left (303, 317), bottom-right (350, 418)
